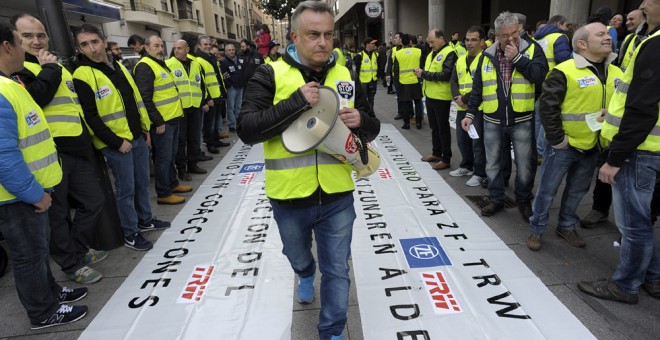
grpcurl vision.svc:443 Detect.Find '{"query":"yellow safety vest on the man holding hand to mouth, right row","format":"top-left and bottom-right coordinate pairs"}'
top-left (481, 44), bottom-right (534, 114)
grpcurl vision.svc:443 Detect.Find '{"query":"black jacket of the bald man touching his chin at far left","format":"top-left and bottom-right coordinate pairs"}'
top-left (12, 53), bottom-right (92, 156)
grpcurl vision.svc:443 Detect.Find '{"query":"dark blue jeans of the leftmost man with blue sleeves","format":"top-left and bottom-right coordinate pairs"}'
top-left (0, 202), bottom-right (62, 324)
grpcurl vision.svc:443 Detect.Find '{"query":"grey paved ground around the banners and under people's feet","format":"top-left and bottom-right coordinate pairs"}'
top-left (0, 87), bottom-right (660, 340)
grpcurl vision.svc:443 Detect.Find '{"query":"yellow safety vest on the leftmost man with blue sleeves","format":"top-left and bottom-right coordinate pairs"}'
top-left (0, 76), bottom-right (62, 202)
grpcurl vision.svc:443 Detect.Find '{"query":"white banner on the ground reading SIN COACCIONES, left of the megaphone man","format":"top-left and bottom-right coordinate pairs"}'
top-left (80, 142), bottom-right (294, 340)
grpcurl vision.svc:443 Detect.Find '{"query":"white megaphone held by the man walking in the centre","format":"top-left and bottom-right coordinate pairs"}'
top-left (282, 86), bottom-right (380, 178)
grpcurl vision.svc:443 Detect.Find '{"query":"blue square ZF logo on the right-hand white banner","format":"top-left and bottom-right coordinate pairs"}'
top-left (399, 237), bottom-right (451, 269)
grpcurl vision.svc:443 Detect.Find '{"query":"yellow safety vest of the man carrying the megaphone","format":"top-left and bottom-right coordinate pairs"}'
top-left (264, 60), bottom-right (355, 199)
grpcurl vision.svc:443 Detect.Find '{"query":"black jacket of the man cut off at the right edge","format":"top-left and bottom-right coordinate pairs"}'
top-left (607, 27), bottom-right (660, 167)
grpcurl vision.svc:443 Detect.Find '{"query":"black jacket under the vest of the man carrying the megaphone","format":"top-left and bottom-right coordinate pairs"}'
top-left (236, 47), bottom-right (380, 144)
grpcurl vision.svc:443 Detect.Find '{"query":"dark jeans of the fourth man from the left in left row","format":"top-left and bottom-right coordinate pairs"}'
top-left (151, 122), bottom-right (179, 198)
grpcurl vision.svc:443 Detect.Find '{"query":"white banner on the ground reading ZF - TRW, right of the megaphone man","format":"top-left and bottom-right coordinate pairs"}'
top-left (351, 124), bottom-right (594, 340)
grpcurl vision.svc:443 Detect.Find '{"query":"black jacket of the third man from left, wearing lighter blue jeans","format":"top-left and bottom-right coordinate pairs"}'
top-left (73, 54), bottom-right (142, 150)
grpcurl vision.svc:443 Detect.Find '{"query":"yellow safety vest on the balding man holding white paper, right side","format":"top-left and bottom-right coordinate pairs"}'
top-left (555, 59), bottom-right (623, 150)
